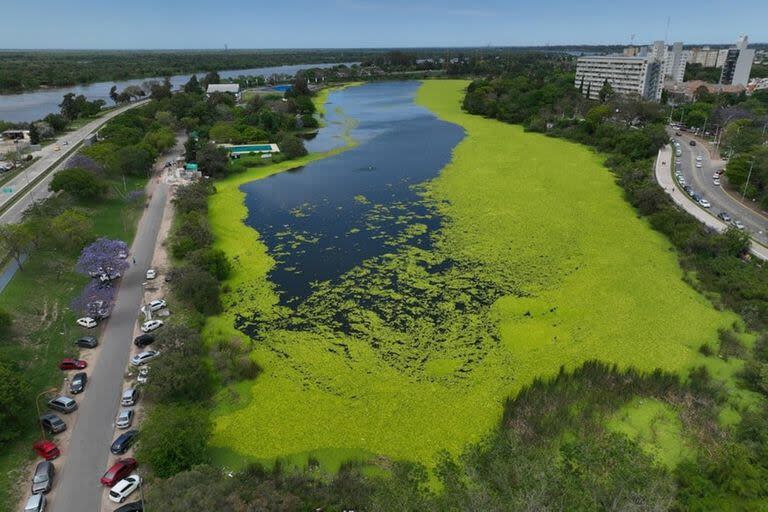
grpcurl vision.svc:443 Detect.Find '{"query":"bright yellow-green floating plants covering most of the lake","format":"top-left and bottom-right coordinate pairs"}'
top-left (205, 80), bottom-right (738, 476)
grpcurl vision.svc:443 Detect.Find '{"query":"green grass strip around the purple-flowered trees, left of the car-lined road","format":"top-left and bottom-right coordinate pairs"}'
top-left (0, 175), bottom-right (146, 511)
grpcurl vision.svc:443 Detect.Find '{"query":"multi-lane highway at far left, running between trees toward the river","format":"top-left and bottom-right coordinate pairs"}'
top-left (0, 102), bottom-right (143, 224)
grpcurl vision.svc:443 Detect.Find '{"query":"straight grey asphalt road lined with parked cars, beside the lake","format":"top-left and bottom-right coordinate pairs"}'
top-left (51, 139), bottom-right (184, 512)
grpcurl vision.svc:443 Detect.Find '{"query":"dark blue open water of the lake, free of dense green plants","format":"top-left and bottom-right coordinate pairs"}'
top-left (241, 82), bottom-right (464, 304)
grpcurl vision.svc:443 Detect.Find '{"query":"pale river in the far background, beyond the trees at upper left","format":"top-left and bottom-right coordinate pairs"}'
top-left (0, 62), bottom-right (353, 123)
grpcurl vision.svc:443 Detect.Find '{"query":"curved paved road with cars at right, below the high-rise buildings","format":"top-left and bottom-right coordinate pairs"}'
top-left (674, 130), bottom-right (768, 246)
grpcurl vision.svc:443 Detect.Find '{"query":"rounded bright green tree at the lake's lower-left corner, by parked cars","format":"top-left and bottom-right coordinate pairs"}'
top-left (137, 405), bottom-right (212, 478)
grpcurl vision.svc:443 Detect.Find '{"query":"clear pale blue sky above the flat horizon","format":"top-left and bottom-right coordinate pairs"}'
top-left (0, 0), bottom-right (768, 49)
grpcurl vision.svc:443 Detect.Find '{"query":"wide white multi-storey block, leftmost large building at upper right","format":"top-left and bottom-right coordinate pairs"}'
top-left (575, 54), bottom-right (666, 101)
